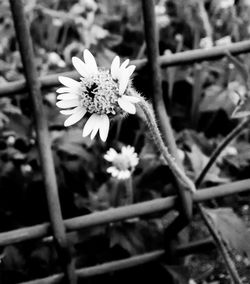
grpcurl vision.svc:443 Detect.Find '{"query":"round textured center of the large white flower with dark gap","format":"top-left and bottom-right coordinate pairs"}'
top-left (80, 70), bottom-right (122, 116)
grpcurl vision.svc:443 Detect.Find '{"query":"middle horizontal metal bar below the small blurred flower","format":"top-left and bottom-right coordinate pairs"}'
top-left (0, 179), bottom-right (250, 246)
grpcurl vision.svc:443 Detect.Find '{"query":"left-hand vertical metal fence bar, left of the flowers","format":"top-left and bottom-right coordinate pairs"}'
top-left (10, 0), bottom-right (76, 284)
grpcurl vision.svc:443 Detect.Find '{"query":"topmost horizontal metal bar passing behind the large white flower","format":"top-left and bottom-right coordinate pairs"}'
top-left (0, 40), bottom-right (250, 97)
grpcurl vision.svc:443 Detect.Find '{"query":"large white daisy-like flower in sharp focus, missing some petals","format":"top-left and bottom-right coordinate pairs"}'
top-left (56, 49), bottom-right (140, 142)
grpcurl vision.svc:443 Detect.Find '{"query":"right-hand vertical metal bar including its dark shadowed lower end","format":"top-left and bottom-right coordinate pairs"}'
top-left (142, 0), bottom-right (192, 270)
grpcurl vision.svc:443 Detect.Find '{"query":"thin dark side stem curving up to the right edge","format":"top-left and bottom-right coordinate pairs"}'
top-left (195, 117), bottom-right (250, 187)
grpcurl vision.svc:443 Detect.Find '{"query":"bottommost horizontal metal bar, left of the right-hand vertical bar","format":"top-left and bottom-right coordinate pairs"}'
top-left (20, 250), bottom-right (164, 284)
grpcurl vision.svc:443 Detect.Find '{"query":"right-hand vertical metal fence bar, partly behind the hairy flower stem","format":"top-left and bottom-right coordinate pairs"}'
top-left (142, 0), bottom-right (192, 228)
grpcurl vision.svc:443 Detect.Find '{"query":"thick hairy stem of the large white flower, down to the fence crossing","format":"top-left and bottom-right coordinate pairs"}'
top-left (139, 98), bottom-right (195, 192)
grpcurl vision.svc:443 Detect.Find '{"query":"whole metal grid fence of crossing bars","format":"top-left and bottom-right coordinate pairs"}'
top-left (0, 0), bottom-right (250, 284)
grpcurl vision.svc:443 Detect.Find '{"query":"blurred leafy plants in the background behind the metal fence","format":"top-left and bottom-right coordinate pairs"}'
top-left (0, 0), bottom-right (250, 283)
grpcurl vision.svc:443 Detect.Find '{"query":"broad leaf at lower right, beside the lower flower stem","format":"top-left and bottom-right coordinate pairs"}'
top-left (205, 208), bottom-right (250, 259)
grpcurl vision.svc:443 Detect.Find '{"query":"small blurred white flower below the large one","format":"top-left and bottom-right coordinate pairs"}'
top-left (104, 146), bottom-right (139, 179)
